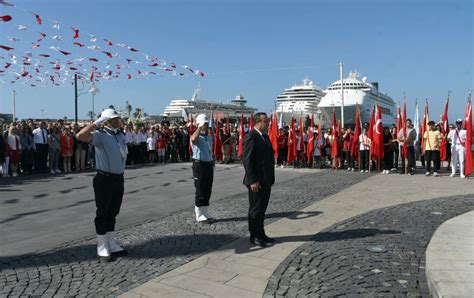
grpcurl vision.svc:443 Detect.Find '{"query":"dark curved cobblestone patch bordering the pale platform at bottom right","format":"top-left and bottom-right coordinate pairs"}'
top-left (265, 195), bottom-right (474, 297)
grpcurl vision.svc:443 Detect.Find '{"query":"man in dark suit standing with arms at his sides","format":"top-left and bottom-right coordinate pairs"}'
top-left (242, 113), bottom-right (275, 247)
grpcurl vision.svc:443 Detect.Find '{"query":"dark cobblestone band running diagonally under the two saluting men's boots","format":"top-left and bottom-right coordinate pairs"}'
top-left (0, 171), bottom-right (367, 296)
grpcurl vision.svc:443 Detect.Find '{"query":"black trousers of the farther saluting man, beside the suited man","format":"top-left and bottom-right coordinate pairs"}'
top-left (193, 160), bottom-right (214, 207)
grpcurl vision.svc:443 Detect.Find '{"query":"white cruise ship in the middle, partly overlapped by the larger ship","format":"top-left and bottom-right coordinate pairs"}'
top-left (276, 78), bottom-right (324, 123)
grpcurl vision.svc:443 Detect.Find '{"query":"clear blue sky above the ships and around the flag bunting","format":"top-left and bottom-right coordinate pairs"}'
top-left (0, 0), bottom-right (474, 120)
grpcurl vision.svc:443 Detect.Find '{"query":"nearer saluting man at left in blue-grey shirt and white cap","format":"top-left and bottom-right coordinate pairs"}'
top-left (77, 109), bottom-right (128, 262)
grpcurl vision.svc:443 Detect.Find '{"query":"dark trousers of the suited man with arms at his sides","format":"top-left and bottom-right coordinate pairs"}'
top-left (247, 186), bottom-right (272, 238)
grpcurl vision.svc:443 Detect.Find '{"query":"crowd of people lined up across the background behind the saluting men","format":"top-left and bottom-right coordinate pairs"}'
top-left (0, 114), bottom-right (466, 177)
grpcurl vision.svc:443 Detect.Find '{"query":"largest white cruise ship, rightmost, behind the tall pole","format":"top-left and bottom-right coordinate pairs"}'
top-left (318, 72), bottom-right (397, 126)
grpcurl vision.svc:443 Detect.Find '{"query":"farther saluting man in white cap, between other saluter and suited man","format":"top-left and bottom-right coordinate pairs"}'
top-left (190, 114), bottom-right (214, 223)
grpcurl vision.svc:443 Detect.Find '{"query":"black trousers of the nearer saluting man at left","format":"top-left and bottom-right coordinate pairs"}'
top-left (93, 173), bottom-right (124, 235)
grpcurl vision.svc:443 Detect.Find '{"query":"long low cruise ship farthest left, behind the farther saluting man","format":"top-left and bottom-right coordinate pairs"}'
top-left (163, 87), bottom-right (257, 119)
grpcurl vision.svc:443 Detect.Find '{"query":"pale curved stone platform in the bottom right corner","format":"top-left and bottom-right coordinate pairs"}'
top-left (426, 211), bottom-right (474, 297)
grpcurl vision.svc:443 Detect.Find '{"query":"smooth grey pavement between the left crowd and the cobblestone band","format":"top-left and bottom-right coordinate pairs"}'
top-left (0, 163), bottom-right (306, 257)
